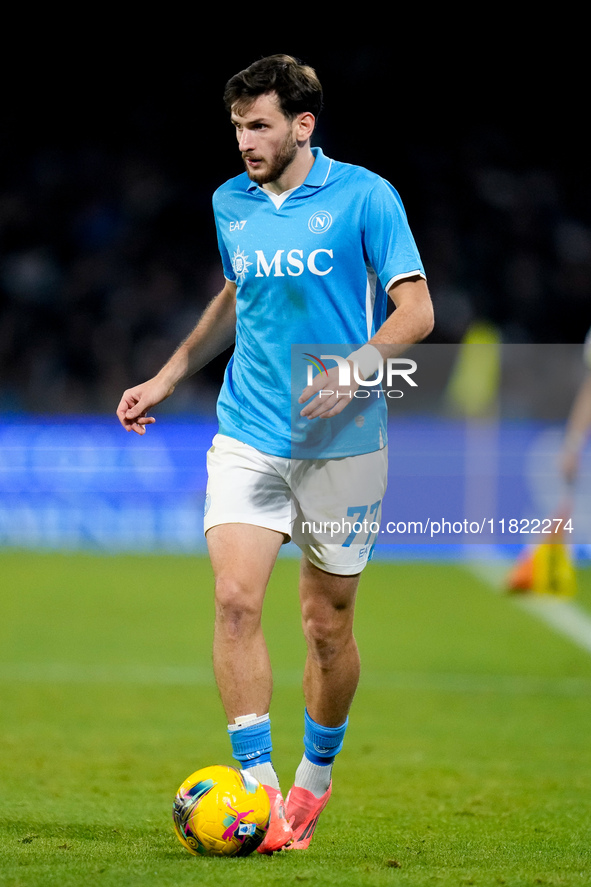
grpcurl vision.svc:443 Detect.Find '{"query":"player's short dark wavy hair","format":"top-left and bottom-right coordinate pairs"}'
top-left (224, 55), bottom-right (322, 119)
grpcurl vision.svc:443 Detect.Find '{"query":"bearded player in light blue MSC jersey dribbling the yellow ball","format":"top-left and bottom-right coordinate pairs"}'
top-left (117, 55), bottom-right (433, 853)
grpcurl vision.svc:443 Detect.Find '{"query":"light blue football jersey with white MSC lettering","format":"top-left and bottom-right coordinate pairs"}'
top-left (213, 148), bottom-right (424, 458)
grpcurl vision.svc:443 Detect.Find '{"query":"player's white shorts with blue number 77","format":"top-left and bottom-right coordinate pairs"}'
top-left (204, 434), bottom-right (388, 575)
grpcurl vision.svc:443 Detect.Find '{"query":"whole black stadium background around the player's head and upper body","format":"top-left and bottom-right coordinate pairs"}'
top-left (0, 30), bottom-right (591, 414)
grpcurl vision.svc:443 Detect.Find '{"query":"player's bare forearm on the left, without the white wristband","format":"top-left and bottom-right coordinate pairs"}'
top-left (158, 284), bottom-right (236, 388)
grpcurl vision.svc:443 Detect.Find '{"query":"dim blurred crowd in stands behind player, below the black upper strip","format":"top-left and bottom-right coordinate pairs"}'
top-left (0, 56), bottom-right (591, 413)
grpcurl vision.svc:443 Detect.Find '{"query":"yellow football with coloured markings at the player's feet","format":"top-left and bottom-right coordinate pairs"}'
top-left (172, 765), bottom-right (271, 856)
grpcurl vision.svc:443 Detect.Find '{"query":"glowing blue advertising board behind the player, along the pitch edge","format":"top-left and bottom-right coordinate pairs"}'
top-left (0, 416), bottom-right (591, 557)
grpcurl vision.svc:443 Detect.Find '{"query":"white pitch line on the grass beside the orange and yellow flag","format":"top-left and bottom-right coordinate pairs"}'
top-left (467, 561), bottom-right (591, 653)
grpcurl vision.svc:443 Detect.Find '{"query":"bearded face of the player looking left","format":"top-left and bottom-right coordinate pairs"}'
top-left (232, 94), bottom-right (298, 185)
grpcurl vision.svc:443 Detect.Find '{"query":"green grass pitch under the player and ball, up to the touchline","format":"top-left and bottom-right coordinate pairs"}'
top-left (0, 552), bottom-right (591, 887)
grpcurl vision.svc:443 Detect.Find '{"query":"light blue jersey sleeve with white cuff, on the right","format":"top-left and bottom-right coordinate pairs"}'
top-left (364, 179), bottom-right (426, 292)
